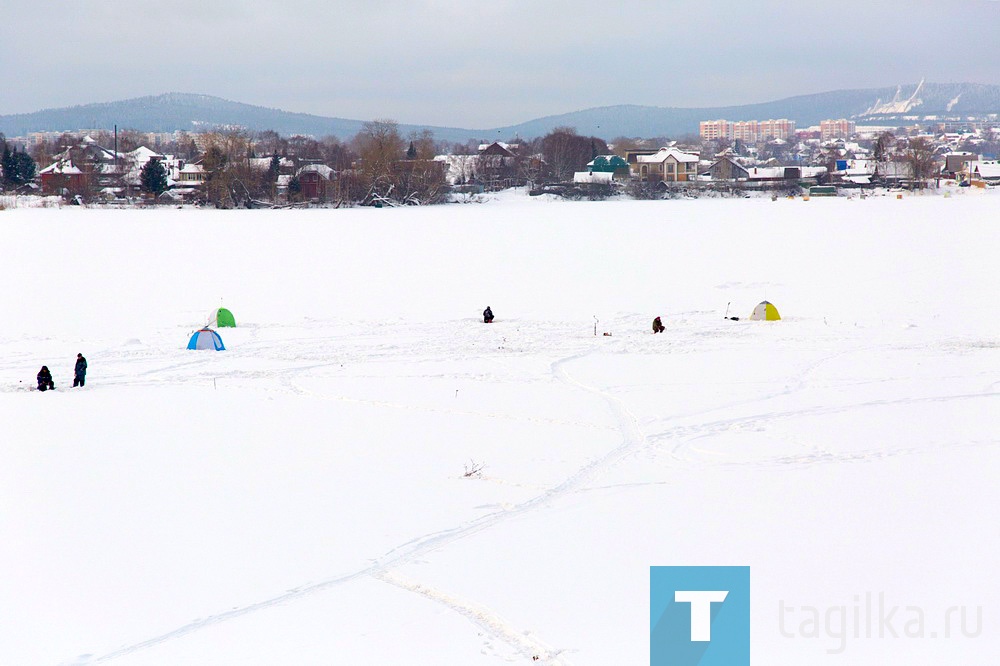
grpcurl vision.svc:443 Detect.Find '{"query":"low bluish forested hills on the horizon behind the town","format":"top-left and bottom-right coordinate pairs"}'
top-left (0, 83), bottom-right (1000, 142)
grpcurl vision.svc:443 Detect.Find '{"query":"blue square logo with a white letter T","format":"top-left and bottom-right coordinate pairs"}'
top-left (649, 567), bottom-right (750, 666)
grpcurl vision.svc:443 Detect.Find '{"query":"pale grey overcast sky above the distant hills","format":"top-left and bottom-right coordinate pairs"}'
top-left (0, 0), bottom-right (1000, 128)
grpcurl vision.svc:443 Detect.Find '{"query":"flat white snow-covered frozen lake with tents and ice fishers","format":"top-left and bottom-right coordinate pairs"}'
top-left (0, 192), bottom-right (1000, 666)
